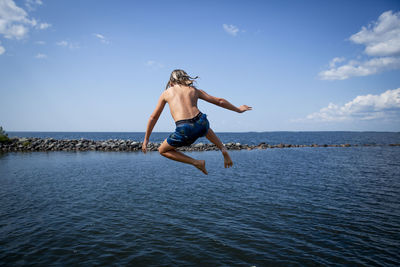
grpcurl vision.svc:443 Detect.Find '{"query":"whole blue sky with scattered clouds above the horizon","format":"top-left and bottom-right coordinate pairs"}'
top-left (0, 0), bottom-right (400, 132)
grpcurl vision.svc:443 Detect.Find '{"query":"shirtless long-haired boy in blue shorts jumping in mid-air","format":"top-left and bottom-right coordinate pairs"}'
top-left (142, 69), bottom-right (252, 174)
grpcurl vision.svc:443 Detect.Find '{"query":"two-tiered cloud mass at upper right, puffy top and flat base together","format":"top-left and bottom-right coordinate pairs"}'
top-left (319, 11), bottom-right (400, 80)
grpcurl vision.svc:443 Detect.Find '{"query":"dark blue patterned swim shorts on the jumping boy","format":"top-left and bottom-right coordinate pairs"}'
top-left (167, 112), bottom-right (210, 147)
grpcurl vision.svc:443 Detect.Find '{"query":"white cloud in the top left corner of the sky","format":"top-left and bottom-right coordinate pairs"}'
top-left (0, 0), bottom-right (50, 40)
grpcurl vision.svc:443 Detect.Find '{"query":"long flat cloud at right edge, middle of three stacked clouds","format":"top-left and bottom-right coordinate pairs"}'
top-left (319, 57), bottom-right (400, 80)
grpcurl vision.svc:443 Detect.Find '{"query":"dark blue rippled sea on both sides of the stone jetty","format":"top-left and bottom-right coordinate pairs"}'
top-left (0, 132), bottom-right (400, 267)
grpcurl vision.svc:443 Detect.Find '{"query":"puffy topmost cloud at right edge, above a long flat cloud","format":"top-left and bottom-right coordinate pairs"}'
top-left (350, 11), bottom-right (400, 56)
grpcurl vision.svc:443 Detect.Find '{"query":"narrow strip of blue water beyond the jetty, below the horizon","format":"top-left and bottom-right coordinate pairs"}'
top-left (8, 132), bottom-right (400, 145)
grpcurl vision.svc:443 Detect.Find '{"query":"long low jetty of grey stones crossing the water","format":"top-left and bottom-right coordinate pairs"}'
top-left (0, 137), bottom-right (400, 152)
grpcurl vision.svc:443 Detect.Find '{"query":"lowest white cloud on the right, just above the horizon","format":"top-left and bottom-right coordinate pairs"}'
top-left (302, 88), bottom-right (400, 122)
